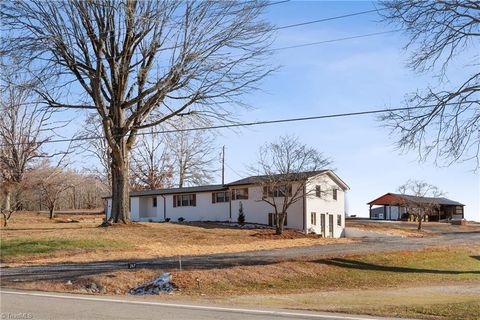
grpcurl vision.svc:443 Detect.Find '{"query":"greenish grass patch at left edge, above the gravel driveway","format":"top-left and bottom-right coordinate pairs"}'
top-left (0, 239), bottom-right (124, 259)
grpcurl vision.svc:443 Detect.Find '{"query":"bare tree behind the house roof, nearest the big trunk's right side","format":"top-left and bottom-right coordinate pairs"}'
top-left (131, 128), bottom-right (173, 190)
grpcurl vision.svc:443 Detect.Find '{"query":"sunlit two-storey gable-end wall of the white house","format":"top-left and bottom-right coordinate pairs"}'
top-left (306, 174), bottom-right (345, 238)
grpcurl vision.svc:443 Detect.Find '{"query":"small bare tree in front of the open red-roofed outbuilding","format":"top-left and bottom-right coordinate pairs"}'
top-left (398, 180), bottom-right (443, 230)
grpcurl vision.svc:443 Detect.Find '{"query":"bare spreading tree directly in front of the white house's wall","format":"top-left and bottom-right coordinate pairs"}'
top-left (250, 136), bottom-right (331, 234)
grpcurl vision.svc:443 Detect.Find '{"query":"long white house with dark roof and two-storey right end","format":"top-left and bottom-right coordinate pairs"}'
top-left (106, 170), bottom-right (349, 238)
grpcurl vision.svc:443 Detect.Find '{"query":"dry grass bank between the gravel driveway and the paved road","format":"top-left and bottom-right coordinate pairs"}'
top-left (9, 245), bottom-right (480, 305)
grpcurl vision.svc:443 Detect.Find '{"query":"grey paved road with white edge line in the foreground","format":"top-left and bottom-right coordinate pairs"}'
top-left (0, 290), bottom-right (408, 320)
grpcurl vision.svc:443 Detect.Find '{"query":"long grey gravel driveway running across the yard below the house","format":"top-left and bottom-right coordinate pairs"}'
top-left (0, 231), bottom-right (480, 286)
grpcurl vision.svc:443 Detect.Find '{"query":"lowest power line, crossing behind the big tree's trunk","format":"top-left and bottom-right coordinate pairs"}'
top-left (0, 103), bottom-right (456, 147)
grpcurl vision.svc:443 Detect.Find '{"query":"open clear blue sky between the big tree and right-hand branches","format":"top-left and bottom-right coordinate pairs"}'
top-left (52, 1), bottom-right (480, 220)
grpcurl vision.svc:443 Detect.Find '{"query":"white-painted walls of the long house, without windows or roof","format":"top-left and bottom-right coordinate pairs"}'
top-left (106, 173), bottom-right (345, 238)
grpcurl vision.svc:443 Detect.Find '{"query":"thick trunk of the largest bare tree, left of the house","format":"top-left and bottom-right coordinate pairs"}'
top-left (110, 153), bottom-right (130, 223)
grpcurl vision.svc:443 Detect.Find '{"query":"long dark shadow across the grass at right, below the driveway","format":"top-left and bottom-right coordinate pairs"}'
top-left (315, 257), bottom-right (480, 275)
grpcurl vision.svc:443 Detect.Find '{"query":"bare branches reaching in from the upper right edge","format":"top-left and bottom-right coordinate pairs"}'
top-left (381, 0), bottom-right (480, 168)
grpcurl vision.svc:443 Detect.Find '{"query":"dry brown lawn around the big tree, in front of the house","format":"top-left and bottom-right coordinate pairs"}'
top-left (1, 212), bottom-right (352, 266)
